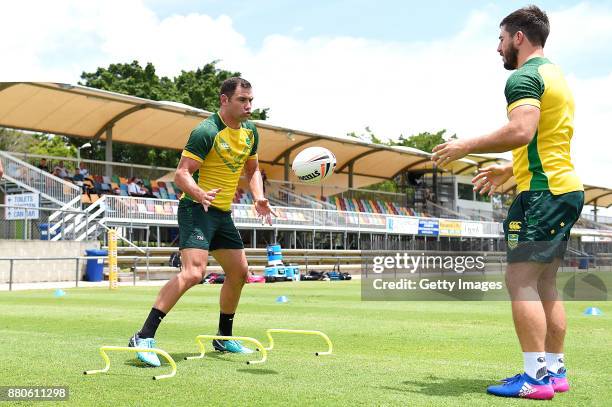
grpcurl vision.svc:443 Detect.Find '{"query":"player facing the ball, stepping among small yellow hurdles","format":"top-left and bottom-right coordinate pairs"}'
top-left (129, 78), bottom-right (274, 366)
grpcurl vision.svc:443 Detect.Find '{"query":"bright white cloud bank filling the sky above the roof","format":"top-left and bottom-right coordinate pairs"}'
top-left (0, 1), bottom-right (612, 186)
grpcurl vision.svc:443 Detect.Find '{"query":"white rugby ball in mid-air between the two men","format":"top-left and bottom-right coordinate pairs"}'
top-left (291, 147), bottom-right (336, 184)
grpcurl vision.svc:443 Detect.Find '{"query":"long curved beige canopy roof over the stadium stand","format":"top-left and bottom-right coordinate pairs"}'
top-left (0, 82), bottom-right (477, 192)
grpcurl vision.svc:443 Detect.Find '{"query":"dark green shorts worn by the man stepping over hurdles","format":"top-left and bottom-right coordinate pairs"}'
top-left (178, 199), bottom-right (244, 251)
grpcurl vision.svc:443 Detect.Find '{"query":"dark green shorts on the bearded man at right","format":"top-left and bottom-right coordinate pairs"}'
top-left (504, 191), bottom-right (584, 263)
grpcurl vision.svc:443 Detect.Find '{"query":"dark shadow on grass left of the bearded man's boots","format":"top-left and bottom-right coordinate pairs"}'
top-left (381, 376), bottom-right (494, 396)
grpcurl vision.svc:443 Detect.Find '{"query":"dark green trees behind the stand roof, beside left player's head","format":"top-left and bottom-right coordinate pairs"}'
top-left (77, 61), bottom-right (269, 167)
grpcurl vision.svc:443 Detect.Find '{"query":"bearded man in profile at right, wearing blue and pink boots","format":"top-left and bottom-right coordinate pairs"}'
top-left (432, 6), bottom-right (584, 399)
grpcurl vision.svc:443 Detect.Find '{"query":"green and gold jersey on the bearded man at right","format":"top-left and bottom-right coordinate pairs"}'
top-left (505, 57), bottom-right (583, 195)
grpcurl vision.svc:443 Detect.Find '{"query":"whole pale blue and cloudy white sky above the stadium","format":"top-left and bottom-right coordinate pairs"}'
top-left (0, 0), bottom-right (612, 201)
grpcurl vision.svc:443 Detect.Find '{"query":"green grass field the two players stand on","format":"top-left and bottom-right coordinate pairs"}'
top-left (0, 281), bottom-right (612, 406)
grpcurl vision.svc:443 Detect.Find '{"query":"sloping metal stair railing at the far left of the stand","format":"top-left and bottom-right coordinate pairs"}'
top-left (0, 151), bottom-right (81, 207)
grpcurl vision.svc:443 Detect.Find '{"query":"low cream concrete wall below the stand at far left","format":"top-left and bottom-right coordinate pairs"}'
top-left (0, 239), bottom-right (100, 283)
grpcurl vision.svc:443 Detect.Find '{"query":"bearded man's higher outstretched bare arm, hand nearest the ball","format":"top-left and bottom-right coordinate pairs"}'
top-left (431, 105), bottom-right (540, 166)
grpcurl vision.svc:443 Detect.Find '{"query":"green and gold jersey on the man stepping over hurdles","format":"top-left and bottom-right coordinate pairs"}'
top-left (182, 113), bottom-right (259, 211)
